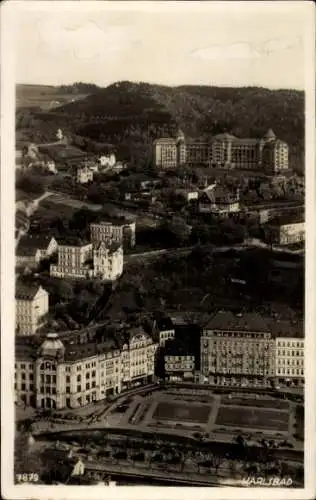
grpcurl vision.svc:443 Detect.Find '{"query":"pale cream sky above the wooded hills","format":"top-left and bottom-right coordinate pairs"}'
top-left (15, 1), bottom-right (314, 89)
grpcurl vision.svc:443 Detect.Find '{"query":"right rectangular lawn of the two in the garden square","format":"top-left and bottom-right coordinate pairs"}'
top-left (216, 406), bottom-right (289, 432)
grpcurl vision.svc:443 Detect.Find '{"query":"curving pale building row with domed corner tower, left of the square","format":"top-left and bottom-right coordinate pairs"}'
top-left (15, 328), bottom-right (158, 409)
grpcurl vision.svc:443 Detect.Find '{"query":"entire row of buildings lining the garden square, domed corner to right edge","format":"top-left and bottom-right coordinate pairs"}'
top-left (15, 311), bottom-right (304, 408)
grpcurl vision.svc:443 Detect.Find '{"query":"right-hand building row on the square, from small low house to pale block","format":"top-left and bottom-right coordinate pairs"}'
top-left (153, 311), bottom-right (304, 387)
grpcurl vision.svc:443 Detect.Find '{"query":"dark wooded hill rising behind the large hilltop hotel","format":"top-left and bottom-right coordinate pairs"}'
top-left (14, 82), bottom-right (304, 169)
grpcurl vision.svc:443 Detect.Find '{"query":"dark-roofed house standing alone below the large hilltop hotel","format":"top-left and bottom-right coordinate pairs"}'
top-left (198, 184), bottom-right (239, 215)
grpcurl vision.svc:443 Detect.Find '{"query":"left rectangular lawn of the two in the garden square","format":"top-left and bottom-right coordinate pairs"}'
top-left (153, 401), bottom-right (211, 424)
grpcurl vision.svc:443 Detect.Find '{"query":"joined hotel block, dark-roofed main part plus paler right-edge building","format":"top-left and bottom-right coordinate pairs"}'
top-left (200, 311), bottom-right (304, 387)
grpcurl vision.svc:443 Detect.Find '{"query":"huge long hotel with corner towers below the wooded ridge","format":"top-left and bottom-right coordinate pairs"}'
top-left (154, 129), bottom-right (289, 174)
